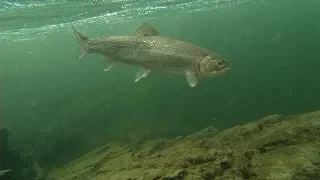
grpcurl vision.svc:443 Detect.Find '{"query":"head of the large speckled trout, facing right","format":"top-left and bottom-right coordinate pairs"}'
top-left (198, 55), bottom-right (231, 77)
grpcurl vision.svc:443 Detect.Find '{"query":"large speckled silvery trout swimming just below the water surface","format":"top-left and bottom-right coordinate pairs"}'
top-left (72, 23), bottom-right (231, 87)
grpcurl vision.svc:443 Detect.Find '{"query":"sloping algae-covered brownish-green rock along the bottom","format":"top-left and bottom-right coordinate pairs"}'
top-left (49, 111), bottom-right (320, 180)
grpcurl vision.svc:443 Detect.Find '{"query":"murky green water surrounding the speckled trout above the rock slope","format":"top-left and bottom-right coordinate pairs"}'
top-left (0, 0), bottom-right (320, 172)
